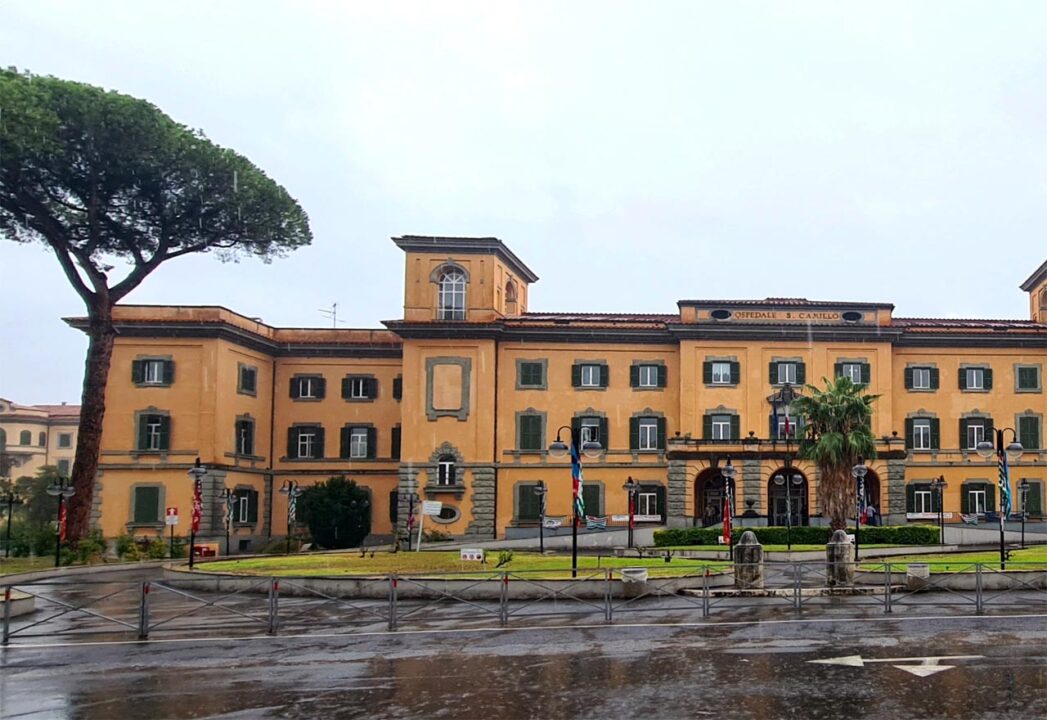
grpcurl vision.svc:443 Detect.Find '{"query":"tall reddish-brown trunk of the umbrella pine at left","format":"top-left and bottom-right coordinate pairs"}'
top-left (66, 297), bottom-right (116, 544)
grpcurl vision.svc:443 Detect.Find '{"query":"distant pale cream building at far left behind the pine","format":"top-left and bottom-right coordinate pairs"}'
top-left (0, 398), bottom-right (80, 478)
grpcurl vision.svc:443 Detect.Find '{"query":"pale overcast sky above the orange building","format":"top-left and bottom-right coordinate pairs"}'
top-left (0, 0), bottom-right (1047, 403)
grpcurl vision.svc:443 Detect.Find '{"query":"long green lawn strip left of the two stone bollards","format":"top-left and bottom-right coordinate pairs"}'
top-left (197, 552), bottom-right (727, 578)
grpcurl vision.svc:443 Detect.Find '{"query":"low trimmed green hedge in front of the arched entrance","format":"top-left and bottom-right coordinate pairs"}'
top-left (654, 525), bottom-right (938, 547)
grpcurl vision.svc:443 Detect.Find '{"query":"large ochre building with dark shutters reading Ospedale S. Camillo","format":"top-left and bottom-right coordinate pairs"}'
top-left (70, 237), bottom-right (1047, 550)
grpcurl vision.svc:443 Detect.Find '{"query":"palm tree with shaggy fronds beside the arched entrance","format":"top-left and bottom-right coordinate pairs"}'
top-left (793, 377), bottom-right (879, 531)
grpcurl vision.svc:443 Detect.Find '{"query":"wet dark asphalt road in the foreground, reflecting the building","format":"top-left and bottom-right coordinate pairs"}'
top-left (0, 614), bottom-right (1047, 720)
